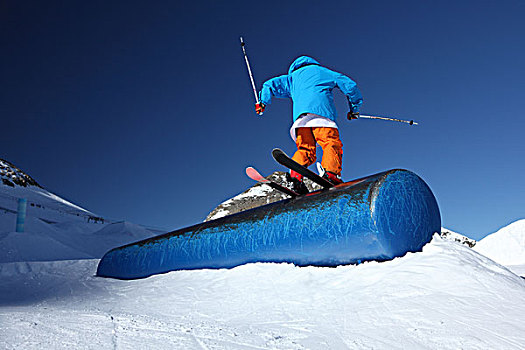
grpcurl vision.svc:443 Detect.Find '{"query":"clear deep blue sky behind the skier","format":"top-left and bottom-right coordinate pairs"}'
top-left (0, 0), bottom-right (525, 238)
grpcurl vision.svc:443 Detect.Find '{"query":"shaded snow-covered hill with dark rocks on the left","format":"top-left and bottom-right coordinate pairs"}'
top-left (0, 160), bottom-right (161, 263)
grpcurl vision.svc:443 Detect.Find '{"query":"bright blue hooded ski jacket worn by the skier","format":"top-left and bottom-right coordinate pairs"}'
top-left (260, 56), bottom-right (363, 122)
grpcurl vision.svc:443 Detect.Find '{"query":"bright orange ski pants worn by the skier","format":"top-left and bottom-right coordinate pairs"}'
top-left (292, 127), bottom-right (343, 175)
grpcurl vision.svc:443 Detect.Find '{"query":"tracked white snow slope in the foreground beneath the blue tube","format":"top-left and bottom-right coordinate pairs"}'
top-left (0, 236), bottom-right (525, 349)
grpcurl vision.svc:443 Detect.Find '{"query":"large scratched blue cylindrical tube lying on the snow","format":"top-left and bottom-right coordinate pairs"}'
top-left (97, 170), bottom-right (441, 279)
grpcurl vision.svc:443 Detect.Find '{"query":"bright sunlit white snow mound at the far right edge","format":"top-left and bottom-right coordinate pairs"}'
top-left (474, 219), bottom-right (525, 265)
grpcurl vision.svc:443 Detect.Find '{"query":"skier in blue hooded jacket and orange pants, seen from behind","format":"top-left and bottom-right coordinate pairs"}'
top-left (255, 56), bottom-right (363, 194)
